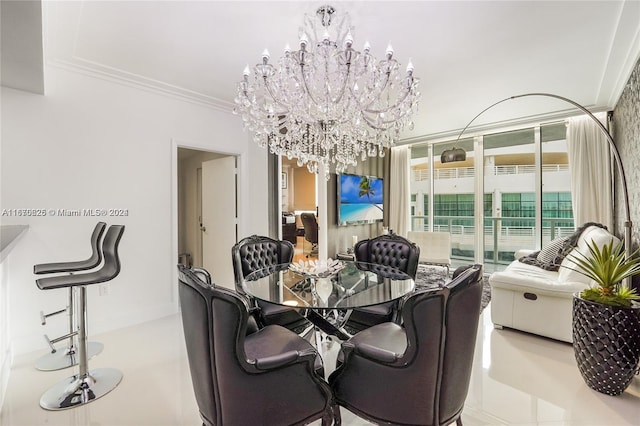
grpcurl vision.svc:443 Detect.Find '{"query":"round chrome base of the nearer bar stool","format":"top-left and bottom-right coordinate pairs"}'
top-left (40, 368), bottom-right (122, 411)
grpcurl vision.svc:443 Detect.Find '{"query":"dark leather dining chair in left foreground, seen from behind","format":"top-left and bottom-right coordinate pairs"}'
top-left (178, 265), bottom-right (332, 426)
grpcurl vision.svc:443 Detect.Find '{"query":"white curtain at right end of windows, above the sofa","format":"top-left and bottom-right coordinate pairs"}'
top-left (567, 116), bottom-right (613, 230)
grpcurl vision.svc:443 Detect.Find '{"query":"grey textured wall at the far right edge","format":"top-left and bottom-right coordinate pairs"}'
top-left (613, 56), bottom-right (640, 250)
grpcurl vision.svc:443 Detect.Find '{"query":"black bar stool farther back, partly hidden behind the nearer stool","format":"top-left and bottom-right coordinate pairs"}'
top-left (33, 222), bottom-right (107, 371)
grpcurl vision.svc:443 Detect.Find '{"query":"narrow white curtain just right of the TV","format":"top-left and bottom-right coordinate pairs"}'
top-left (388, 146), bottom-right (411, 237)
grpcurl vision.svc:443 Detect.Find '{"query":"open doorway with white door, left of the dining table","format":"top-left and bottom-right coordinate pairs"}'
top-left (177, 147), bottom-right (237, 288)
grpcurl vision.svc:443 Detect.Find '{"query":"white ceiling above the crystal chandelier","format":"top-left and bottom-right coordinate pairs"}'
top-left (17, 0), bottom-right (640, 140)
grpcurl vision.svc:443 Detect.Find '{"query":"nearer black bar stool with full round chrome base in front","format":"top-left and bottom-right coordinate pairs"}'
top-left (36, 225), bottom-right (124, 410)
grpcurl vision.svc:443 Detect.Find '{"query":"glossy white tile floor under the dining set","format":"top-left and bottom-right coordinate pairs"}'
top-left (0, 305), bottom-right (640, 426)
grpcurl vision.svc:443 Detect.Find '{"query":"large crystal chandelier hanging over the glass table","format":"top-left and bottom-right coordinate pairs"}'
top-left (234, 6), bottom-right (420, 175)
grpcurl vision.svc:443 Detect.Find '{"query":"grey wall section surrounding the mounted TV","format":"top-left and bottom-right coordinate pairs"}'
top-left (327, 156), bottom-right (389, 258)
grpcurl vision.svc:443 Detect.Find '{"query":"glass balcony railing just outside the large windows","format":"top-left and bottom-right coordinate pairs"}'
top-left (411, 216), bottom-right (575, 269)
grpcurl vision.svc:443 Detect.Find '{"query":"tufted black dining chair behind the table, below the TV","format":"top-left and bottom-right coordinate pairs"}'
top-left (345, 234), bottom-right (420, 334)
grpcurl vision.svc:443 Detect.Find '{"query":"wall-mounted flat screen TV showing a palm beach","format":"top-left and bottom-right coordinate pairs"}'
top-left (337, 174), bottom-right (384, 225)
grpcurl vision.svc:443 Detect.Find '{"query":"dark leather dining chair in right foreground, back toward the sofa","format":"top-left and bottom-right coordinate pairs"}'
top-left (329, 265), bottom-right (482, 425)
